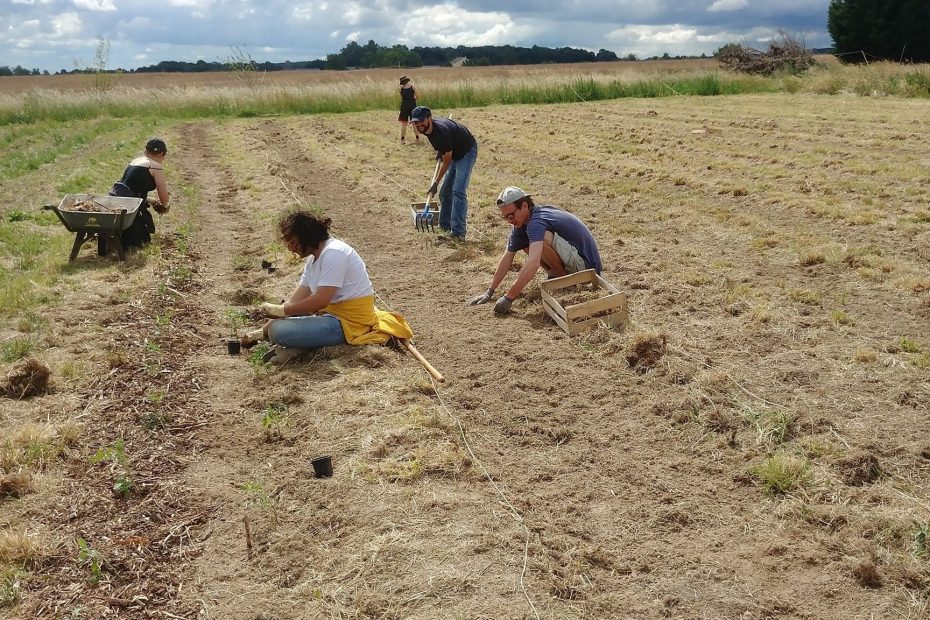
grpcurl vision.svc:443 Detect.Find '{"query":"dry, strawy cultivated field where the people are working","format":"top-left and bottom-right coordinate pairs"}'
top-left (0, 61), bottom-right (930, 620)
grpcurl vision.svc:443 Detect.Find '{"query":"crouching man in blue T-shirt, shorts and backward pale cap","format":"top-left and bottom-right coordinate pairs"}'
top-left (468, 187), bottom-right (601, 314)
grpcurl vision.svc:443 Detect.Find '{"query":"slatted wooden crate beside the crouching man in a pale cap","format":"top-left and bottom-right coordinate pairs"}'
top-left (539, 269), bottom-right (629, 336)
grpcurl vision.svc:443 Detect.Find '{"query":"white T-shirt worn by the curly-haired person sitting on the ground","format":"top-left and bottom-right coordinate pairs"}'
top-left (300, 238), bottom-right (375, 303)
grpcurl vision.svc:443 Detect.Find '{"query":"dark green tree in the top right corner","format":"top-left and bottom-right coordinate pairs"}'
top-left (827, 0), bottom-right (930, 63)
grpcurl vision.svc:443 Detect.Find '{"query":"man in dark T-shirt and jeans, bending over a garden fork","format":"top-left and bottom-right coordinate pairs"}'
top-left (410, 105), bottom-right (478, 241)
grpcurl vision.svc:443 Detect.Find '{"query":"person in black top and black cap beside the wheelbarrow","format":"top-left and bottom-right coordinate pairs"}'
top-left (104, 138), bottom-right (171, 255)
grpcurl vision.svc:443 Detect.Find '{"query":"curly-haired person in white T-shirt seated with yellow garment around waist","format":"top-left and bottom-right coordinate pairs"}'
top-left (243, 211), bottom-right (412, 364)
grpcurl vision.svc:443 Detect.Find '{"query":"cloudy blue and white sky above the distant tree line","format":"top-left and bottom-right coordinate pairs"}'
top-left (0, 0), bottom-right (832, 73)
